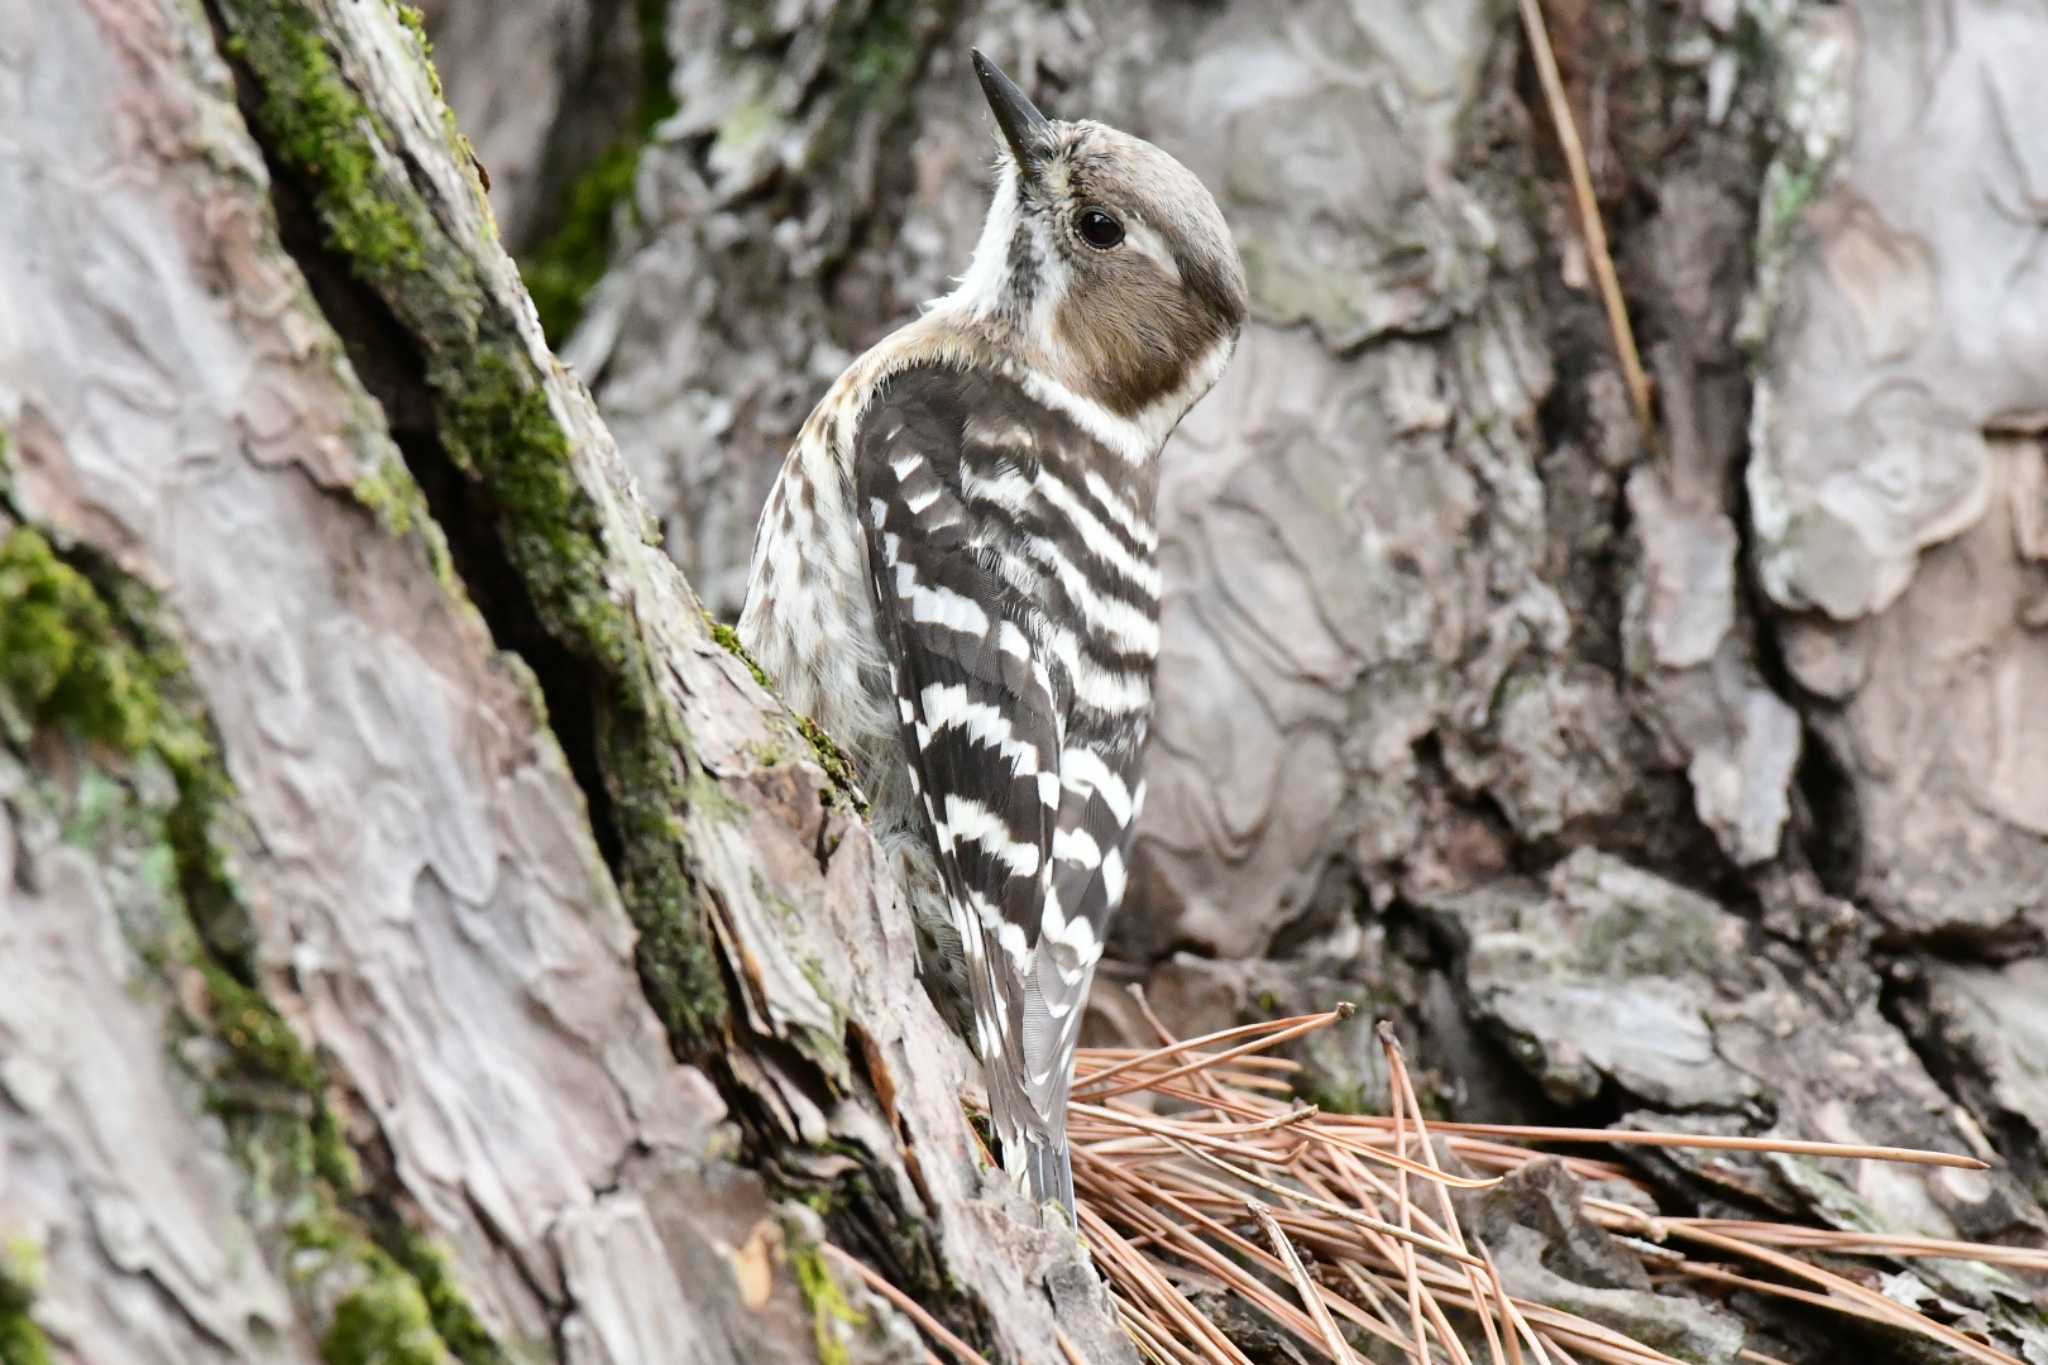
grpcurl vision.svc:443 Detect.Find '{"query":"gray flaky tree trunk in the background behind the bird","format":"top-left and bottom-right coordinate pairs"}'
top-left (448, 0), bottom-right (2048, 1359)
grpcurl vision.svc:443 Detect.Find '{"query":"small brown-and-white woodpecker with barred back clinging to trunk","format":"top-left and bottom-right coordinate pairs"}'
top-left (739, 51), bottom-right (1247, 1218)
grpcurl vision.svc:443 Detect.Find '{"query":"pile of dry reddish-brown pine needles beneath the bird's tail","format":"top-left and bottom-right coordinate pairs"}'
top-left (840, 1005), bottom-right (2048, 1365)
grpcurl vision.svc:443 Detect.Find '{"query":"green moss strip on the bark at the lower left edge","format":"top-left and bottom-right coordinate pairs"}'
top-left (0, 509), bottom-right (502, 1365)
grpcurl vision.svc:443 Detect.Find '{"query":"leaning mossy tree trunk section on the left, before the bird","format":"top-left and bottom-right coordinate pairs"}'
top-left (0, 0), bottom-right (1128, 1365)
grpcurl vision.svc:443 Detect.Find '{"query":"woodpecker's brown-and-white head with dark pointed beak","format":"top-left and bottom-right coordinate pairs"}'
top-left (948, 51), bottom-right (1247, 440)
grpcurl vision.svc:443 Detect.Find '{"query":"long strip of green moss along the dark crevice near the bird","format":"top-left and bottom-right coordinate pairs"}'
top-left (217, 0), bottom-right (727, 1050)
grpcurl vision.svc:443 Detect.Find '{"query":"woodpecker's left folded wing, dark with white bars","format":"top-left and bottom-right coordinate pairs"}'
top-left (854, 370), bottom-right (1065, 1101)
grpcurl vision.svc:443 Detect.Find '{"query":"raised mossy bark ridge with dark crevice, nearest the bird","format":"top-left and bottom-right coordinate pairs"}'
top-left (178, 0), bottom-right (1122, 1355)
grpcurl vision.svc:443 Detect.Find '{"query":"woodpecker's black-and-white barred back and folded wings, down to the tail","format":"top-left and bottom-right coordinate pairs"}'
top-left (856, 360), bottom-right (1159, 1203)
